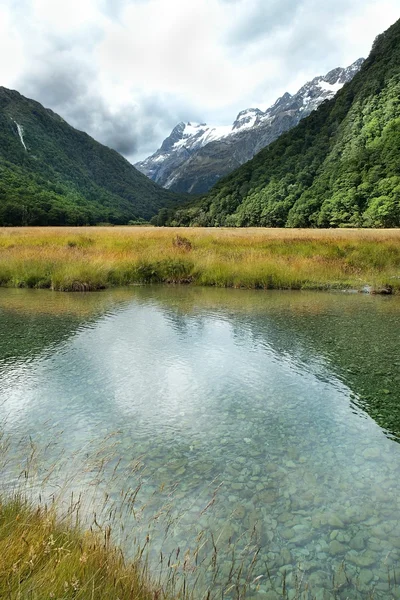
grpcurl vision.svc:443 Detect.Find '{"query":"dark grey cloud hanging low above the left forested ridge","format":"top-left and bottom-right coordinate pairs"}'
top-left (18, 53), bottom-right (200, 162)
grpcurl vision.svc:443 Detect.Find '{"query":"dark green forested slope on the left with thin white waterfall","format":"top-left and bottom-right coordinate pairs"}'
top-left (0, 87), bottom-right (182, 225)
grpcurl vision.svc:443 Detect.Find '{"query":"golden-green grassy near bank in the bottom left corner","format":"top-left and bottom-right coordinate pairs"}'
top-left (0, 496), bottom-right (164, 600)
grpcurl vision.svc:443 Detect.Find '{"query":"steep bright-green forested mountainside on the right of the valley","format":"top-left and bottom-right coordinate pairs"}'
top-left (168, 21), bottom-right (400, 227)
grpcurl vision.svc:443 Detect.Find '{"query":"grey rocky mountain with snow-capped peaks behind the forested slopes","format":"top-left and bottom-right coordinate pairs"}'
top-left (135, 58), bottom-right (364, 194)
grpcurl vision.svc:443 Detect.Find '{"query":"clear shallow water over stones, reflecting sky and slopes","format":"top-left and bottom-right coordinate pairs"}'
top-left (0, 287), bottom-right (400, 600)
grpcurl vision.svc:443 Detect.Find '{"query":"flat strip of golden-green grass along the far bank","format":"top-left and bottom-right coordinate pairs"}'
top-left (0, 227), bottom-right (400, 293)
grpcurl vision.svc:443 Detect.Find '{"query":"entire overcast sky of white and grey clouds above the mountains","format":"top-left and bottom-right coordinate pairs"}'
top-left (0, 0), bottom-right (400, 162)
